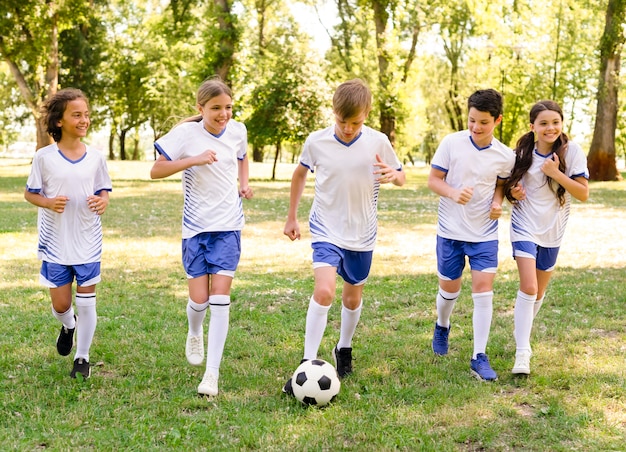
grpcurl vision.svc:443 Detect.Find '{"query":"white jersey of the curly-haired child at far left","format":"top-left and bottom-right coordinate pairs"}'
top-left (26, 143), bottom-right (112, 265)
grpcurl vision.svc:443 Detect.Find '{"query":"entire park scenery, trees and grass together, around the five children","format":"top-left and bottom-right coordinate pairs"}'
top-left (0, 0), bottom-right (626, 451)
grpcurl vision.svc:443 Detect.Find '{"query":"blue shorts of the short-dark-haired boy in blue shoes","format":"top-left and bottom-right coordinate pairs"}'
top-left (437, 236), bottom-right (498, 281)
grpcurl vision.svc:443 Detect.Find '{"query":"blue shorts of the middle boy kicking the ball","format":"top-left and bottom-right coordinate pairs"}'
top-left (311, 242), bottom-right (374, 286)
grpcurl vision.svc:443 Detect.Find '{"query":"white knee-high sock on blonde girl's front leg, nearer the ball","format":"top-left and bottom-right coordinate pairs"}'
top-left (206, 295), bottom-right (230, 378)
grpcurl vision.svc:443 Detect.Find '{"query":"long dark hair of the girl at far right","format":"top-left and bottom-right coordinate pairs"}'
top-left (504, 100), bottom-right (569, 206)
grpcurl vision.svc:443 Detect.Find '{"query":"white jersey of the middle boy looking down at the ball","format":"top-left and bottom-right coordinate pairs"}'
top-left (300, 125), bottom-right (402, 251)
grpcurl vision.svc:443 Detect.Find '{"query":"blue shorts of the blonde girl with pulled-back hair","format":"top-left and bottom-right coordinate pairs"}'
top-left (183, 231), bottom-right (241, 279)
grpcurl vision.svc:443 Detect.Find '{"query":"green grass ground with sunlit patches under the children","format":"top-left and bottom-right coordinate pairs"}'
top-left (0, 160), bottom-right (626, 451)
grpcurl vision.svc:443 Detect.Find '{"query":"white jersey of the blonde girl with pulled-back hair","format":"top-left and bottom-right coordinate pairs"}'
top-left (154, 119), bottom-right (247, 239)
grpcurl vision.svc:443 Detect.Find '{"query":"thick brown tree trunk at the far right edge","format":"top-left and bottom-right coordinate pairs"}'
top-left (587, 0), bottom-right (626, 181)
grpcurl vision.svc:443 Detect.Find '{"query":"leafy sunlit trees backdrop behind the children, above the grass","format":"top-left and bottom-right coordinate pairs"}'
top-left (0, 0), bottom-right (626, 180)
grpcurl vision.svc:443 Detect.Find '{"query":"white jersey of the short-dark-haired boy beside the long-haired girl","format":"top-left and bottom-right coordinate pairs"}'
top-left (431, 130), bottom-right (515, 243)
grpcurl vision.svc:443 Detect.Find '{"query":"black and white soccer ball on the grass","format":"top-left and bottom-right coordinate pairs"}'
top-left (291, 359), bottom-right (341, 406)
